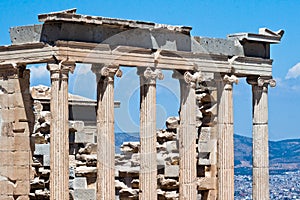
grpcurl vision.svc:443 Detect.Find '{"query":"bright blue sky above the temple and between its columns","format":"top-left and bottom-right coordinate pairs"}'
top-left (0, 0), bottom-right (300, 140)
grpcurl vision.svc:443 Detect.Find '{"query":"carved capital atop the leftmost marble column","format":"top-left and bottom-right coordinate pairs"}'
top-left (47, 61), bottom-right (75, 80)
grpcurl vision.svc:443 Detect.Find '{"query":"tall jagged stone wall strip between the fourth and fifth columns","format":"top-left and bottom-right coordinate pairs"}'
top-left (196, 74), bottom-right (218, 199)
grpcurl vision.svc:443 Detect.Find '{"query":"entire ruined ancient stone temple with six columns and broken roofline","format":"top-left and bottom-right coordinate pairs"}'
top-left (0, 9), bottom-right (283, 200)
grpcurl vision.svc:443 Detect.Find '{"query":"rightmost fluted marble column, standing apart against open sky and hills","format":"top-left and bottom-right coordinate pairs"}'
top-left (247, 77), bottom-right (276, 200)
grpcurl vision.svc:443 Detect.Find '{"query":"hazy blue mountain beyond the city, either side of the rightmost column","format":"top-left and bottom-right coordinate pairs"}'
top-left (234, 135), bottom-right (300, 170)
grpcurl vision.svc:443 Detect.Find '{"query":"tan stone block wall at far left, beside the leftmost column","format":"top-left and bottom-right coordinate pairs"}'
top-left (0, 67), bottom-right (34, 200)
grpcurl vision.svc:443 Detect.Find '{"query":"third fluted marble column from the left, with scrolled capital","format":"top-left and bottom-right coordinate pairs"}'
top-left (138, 67), bottom-right (164, 199)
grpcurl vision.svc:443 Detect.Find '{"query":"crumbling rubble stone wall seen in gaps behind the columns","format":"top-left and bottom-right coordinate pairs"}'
top-left (25, 80), bottom-right (217, 200)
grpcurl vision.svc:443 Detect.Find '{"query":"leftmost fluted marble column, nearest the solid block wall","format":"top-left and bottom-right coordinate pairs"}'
top-left (47, 63), bottom-right (75, 200)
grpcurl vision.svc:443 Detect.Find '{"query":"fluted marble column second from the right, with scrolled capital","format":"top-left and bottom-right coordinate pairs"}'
top-left (217, 75), bottom-right (238, 200)
